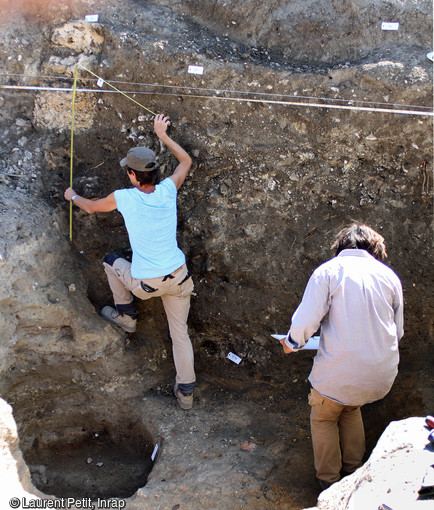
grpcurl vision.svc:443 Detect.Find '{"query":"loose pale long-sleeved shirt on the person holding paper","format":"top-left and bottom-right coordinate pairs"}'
top-left (286, 249), bottom-right (404, 405)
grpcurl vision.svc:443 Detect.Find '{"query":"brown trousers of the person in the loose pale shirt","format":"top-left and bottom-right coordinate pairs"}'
top-left (309, 388), bottom-right (365, 483)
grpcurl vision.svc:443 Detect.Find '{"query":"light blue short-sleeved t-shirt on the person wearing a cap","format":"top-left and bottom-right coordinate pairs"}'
top-left (115, 178), bottom-right (185, 279)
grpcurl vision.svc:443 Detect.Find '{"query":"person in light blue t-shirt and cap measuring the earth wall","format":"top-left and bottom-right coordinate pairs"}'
top-left (65, 114), bottom-right (196, 409)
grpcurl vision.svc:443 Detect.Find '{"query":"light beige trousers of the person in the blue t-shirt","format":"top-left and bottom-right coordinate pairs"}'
top-left (104, 258), bottom-right (196, 384)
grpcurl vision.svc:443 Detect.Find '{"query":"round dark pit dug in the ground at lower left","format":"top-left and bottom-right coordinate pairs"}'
top-left (23, 408), bottom-right (155, 499)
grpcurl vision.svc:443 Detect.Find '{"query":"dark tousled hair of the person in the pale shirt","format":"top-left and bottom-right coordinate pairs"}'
top-left (332, 222), bottom-right (387, 261)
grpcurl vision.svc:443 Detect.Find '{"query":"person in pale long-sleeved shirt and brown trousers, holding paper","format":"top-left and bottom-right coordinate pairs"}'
top-left (281, 223), bottom-right (404, 489)
